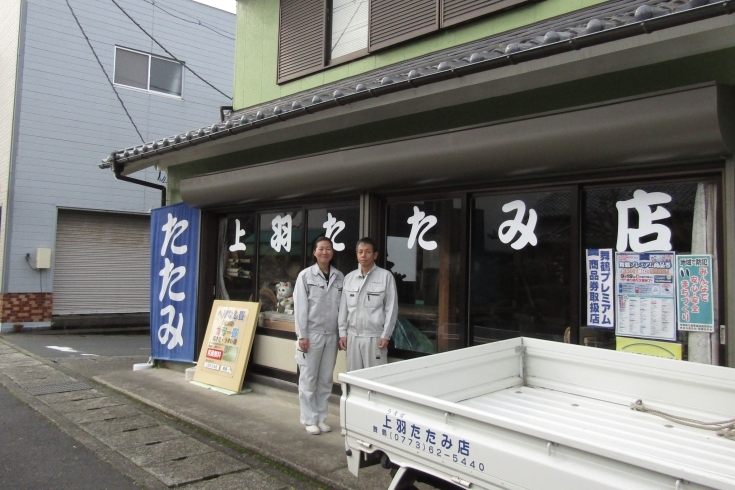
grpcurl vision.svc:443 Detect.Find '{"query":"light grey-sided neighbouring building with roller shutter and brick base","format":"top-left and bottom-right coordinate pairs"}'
top-left (0, 0), bottom-right (235, 331)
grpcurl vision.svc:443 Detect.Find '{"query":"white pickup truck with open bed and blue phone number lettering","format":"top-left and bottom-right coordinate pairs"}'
top-left (339, 337), bottom-right (735, 490)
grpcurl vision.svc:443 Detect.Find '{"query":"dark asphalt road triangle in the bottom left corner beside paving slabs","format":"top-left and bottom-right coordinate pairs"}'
top-left (0, 386), bottom-right (139, 490)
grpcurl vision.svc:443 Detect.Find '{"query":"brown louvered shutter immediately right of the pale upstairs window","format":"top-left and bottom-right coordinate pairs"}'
top-left (369, 0), bottom-right (439, 51)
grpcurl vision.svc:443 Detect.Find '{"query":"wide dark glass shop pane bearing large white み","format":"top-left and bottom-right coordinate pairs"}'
top-left (470, 191), bottom-right (576, 344)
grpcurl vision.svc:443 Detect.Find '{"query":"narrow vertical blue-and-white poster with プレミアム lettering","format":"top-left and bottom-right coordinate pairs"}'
top-left (587, 248), bottom-right (615, 328)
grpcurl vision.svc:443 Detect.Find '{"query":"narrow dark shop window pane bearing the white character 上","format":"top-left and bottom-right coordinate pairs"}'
top-left (216, 213), bottom-right (256, 301)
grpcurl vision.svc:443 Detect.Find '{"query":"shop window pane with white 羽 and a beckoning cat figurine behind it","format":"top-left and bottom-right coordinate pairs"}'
top-left (258, 211), bottom-right (304, 322)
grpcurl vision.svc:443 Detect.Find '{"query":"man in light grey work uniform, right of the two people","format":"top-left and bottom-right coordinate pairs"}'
top-left (339, 237), bottom-right (398, 371)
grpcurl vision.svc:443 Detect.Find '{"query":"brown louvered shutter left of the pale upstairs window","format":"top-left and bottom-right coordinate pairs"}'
top-left (278, 0), bottom-right (327, 83)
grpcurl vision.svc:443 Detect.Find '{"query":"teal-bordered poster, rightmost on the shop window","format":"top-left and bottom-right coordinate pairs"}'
top-left (676, 255), bottom-right (715, 333)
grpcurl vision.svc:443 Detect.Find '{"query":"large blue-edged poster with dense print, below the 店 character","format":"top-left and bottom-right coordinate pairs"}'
top-left (615, 252), bottom-right (676, 340)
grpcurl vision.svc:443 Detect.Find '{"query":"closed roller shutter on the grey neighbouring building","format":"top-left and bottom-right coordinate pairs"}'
top-left (53, 209), bottom-right (151, 315)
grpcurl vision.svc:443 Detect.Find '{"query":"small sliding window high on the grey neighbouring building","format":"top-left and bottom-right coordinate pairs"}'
top-left (114, 47), bottom-right (184, 97)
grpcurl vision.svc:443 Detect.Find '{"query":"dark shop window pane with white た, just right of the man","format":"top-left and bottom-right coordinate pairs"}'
top-left (385, 199), bottom-right (466, 353)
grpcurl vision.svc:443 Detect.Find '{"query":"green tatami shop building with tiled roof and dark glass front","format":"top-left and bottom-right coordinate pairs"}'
top-left (109, 0), bottom-right (735, 380)
